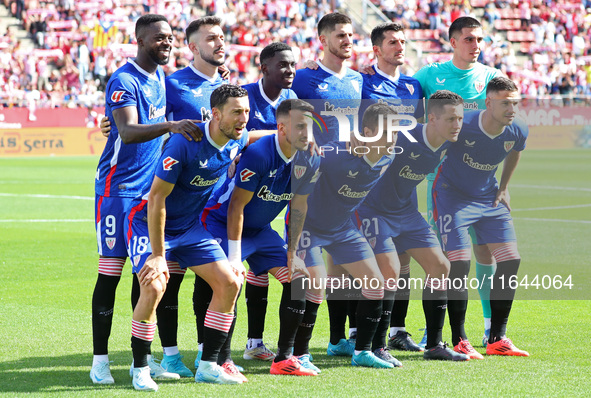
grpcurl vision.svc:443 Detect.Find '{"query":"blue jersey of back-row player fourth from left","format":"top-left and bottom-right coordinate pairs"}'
top-left (292, 62), bottom-right (363, 146)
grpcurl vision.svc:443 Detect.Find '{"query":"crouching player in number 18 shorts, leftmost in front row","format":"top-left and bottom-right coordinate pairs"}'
top-left (127, 85), bottom-right (249, 391)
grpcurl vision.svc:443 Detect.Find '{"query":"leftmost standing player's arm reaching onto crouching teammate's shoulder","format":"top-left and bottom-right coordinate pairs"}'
top-left (111, 106), bottom-right (203, 144)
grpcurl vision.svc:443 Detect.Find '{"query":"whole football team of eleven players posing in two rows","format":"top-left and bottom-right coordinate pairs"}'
top-left (81, 3), bottom-right (548, 391)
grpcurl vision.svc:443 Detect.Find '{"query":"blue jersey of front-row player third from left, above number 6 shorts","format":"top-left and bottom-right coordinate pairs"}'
top-left (305, 142), bottom-right (394, 234)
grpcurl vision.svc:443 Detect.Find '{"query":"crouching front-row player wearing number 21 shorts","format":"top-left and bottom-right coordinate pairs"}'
top-left (357, 90), bottom-right (469, 361)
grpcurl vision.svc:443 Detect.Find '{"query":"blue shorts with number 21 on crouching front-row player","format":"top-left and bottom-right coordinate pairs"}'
top-left (357, 206), bottom-right (439, 254)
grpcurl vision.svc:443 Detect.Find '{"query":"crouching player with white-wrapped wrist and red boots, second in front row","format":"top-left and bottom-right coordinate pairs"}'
top-left (202, 99), bottom-right (320, 376)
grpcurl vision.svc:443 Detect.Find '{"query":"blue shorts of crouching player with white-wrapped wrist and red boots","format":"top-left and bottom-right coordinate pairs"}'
top-left (207, 220), bottom-right (287, 276)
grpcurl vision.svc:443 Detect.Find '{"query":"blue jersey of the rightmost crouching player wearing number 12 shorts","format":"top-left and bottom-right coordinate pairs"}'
top-left (435, 111), bottom-right (529, 200)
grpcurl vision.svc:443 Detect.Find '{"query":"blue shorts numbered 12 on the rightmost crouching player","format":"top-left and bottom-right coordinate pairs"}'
top-left (434, 189), bottom-right (517, 251)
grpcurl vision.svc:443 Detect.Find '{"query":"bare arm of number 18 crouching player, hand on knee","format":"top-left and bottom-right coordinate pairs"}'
top-left (138, 176), bottom-right (174, 286)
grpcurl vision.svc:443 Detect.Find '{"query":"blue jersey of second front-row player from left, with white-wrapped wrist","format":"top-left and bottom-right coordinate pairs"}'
top-left (203, 134), bottom-right (320, 231)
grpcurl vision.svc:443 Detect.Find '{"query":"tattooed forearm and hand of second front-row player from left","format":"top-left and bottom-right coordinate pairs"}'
top-left (287, 194), bottom-right (310, 281)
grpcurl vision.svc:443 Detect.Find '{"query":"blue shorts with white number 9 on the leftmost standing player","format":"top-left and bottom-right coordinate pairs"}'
top-left (94, 195), bottom-right (133, 257)
